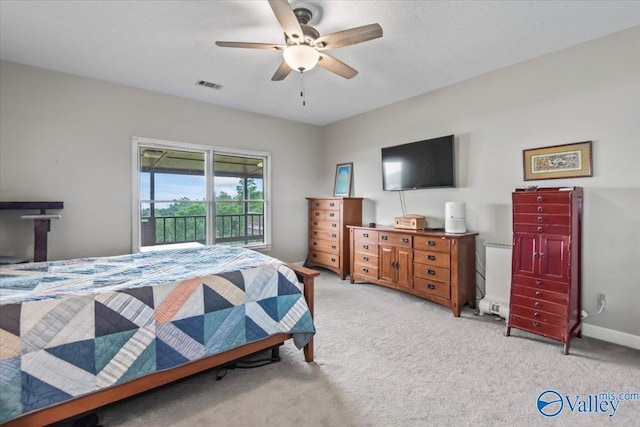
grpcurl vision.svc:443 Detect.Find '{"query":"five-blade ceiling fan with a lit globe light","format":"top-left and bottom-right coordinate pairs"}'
top-left (216, 0), bottom-right (382, 81)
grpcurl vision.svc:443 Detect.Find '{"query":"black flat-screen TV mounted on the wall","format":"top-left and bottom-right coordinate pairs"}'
top-left (382, 135), bottom-right (456, 191)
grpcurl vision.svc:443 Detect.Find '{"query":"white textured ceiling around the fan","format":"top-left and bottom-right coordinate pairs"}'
top-left (0, 0), bottom-right (640, 125)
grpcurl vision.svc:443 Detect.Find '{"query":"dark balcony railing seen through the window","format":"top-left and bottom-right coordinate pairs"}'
top-left (142, 213), bottom-right (264, 246)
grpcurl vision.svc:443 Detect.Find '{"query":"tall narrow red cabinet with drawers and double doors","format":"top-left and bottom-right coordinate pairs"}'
top-left (506, 187), bottom-right (582, 354)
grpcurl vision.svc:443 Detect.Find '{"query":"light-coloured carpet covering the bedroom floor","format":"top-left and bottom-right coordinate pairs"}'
top-left (92, 272), bottom-right (640, 427)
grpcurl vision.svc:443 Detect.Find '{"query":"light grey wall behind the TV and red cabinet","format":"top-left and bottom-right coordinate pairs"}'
top-left (322, 27), bottom-right (640, 343)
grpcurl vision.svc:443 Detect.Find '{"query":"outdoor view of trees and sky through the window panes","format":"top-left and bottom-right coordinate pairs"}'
top-left (140, 149), bottom-right (265, 246)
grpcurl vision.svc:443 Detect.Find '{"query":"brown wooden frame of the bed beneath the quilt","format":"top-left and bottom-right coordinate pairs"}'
top-left (0, 264), bottom-right (320, 427)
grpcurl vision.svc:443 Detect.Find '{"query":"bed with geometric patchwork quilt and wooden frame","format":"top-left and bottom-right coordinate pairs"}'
top-left (0, 246), bottom-right (318, 427)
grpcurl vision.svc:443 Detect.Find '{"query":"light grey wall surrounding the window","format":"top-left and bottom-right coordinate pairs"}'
top-left (0, 62), bottom-right (321, 261)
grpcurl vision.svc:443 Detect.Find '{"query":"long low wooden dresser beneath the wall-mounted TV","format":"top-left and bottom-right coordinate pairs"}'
top-left (349, 226), bottom-right (476, 317)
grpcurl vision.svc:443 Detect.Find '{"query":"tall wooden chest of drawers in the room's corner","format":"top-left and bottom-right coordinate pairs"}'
top-left (306, 197), bottom-right (362, 280)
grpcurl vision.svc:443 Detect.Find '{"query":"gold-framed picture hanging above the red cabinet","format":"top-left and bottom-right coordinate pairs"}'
top-left (522, 141), bottom-right (593, 181)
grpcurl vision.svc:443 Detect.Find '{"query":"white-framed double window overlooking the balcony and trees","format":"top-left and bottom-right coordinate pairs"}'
top-left (133, 138), bottom-right (271, 251)
